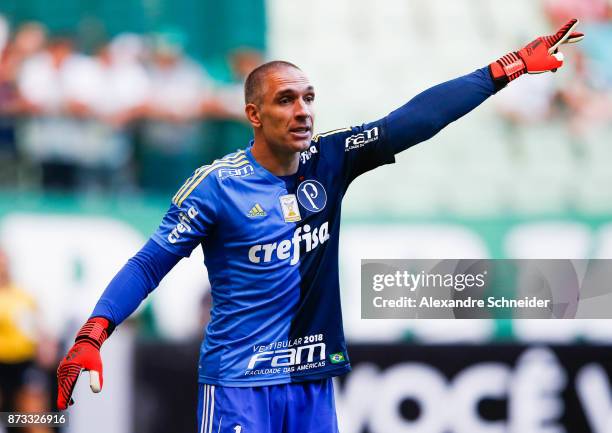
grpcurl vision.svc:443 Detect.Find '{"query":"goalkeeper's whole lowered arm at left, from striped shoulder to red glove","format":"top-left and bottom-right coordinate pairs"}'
top-left (57, 169), bottom-right (218, 410)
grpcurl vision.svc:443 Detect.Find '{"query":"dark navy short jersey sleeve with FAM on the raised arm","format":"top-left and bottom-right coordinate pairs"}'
top-left (313, 118), bottom-right (395, 189)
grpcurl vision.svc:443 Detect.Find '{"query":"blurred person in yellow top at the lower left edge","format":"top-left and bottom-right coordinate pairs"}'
top-left (0, 250), bottom-right (55, 433)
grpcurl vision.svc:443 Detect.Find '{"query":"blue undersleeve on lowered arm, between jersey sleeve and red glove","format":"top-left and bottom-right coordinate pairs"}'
top-left (91, 240), bottom-right (182, 325)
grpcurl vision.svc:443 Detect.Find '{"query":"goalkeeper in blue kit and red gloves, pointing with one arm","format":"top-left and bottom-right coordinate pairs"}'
top-left (57, 20), bottom-right (583, 433)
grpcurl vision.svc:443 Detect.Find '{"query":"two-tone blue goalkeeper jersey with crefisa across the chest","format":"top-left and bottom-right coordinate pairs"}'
top-left (153, 119), bottom-right (395, 386)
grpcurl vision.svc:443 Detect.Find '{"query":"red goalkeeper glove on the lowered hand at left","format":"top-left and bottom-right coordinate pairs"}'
top-left (57, 317), bottom-right (114, 410)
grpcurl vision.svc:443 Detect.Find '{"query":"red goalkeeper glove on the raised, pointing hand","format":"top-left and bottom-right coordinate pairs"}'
top-left (489, 18), bottom-right (584, 88)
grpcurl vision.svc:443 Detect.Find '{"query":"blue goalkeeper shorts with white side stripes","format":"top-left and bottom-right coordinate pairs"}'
top-left (197, 378), bottom-right (338, 433)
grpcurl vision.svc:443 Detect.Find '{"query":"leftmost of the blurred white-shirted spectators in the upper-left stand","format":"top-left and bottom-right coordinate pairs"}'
top-left (18, 36), bottom-right (98, 189)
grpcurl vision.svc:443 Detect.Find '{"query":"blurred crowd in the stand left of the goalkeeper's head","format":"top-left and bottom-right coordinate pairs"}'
top-left (0, 16), bottom-right (262, 192)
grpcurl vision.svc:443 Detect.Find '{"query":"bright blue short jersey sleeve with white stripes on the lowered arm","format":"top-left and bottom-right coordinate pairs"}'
top-left (151, 169), bottom-right (218, 257)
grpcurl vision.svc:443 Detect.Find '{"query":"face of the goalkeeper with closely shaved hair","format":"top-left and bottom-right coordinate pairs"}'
top-left (251, 67), bottom-right (315, 153)
